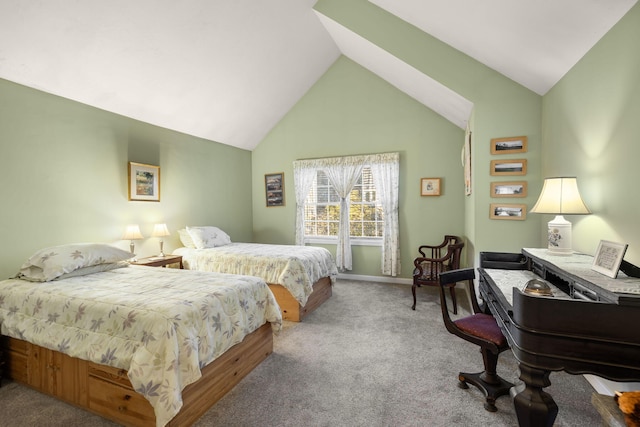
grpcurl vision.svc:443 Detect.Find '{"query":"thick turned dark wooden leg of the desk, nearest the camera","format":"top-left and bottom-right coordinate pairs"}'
top-left (513, 363), bottom-right (558, 427)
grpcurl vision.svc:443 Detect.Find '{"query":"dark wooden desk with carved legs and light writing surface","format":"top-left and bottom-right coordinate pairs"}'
top-left (478, 249), bottom-right (640, 426)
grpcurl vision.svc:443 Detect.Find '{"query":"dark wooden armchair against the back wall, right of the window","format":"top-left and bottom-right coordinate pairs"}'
top-left (411, 235), bottom-right (464, 314)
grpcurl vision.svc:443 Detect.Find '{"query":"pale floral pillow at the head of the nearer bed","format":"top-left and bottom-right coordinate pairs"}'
top-left (18, 243), bottom-right (132, 282)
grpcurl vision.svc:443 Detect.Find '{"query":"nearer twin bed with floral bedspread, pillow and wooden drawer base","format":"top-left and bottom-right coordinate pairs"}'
top-left (0, 245), bottom-right (282, 426)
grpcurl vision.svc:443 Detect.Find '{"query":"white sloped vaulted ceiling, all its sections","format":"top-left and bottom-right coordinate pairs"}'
top-left (0, 0), bottom-right (637, 150)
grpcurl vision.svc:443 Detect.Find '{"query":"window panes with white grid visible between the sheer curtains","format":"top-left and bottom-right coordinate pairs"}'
top-left (304, 166), bottom-right (383, 242)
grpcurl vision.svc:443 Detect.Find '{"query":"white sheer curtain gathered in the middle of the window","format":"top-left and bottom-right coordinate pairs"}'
top-left (323, 157), bottom-right (363, 270)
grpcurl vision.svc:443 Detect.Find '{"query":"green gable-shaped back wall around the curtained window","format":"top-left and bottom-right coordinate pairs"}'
top-left (253, 57), bottom-right (464, 276)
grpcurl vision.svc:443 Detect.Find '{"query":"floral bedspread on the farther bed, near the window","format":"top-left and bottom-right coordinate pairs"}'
top-left (173, 242), bottom-right (338, 306)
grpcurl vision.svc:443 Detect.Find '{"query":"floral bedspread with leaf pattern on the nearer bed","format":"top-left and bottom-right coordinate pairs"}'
top-left (0, 266), bottom-right (282, 426)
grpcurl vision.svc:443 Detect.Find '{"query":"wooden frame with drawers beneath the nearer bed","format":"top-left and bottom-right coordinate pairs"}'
top-left (0, 322), bottom-right (273, 426)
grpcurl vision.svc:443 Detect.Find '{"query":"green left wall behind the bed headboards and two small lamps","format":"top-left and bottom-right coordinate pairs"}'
top-left (0, 79), bottom-right (252, 278)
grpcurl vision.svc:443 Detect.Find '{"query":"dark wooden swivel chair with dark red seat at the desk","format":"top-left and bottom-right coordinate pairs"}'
top-left (440, 268), bottom-right (513, 412)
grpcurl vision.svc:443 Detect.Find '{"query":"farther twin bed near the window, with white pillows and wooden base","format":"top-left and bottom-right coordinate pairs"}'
top-left (173, 227), bottom-right (338, 322)
